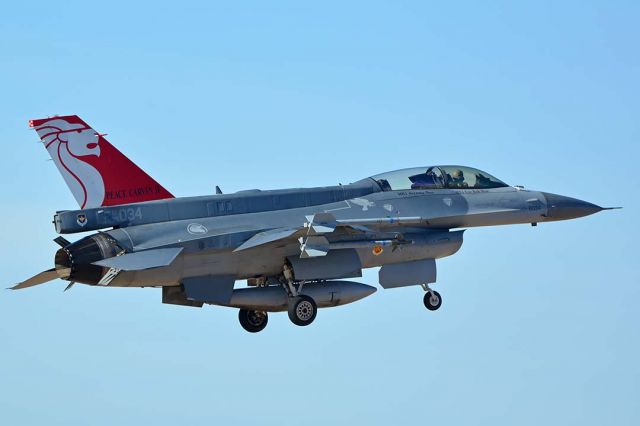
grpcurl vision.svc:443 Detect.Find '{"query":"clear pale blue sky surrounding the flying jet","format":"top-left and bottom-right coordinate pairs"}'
top-left (0, 1), bottom-right (640, 425)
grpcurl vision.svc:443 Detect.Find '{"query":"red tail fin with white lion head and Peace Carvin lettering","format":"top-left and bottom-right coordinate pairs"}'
top-left (29, 115), bottom-right (173, 209)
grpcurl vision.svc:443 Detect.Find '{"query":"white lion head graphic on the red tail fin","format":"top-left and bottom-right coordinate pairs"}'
top-left (36, 118), bottom-right (105, 209)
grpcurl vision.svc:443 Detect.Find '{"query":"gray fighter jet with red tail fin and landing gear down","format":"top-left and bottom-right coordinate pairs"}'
top-left (12, 115), bottom-right (616, 333)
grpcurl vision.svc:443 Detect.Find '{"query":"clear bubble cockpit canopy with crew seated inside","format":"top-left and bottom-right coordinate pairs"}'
top-left (371, 166), bottom-right (509, 191)
